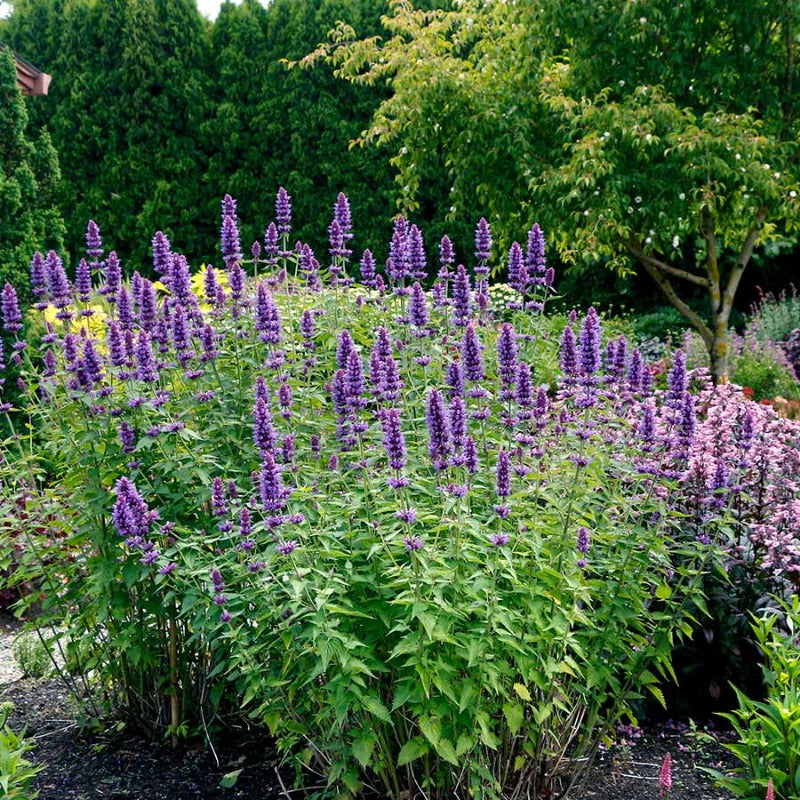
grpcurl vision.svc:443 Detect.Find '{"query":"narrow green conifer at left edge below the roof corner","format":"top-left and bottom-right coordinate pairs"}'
top-left (0, 48), bottom-right (64, 290)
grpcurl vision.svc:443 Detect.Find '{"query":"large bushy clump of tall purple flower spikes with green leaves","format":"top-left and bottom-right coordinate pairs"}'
top-left (2, 195), bottom-right (800, 798)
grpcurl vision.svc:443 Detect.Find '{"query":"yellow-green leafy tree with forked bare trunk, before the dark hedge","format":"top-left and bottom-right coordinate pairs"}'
top-left (310, 0), bottom-right (800, 378)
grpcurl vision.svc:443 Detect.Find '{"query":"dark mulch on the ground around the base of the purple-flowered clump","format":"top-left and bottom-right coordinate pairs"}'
top-left (0, 680), bottom-right (731, 800)
